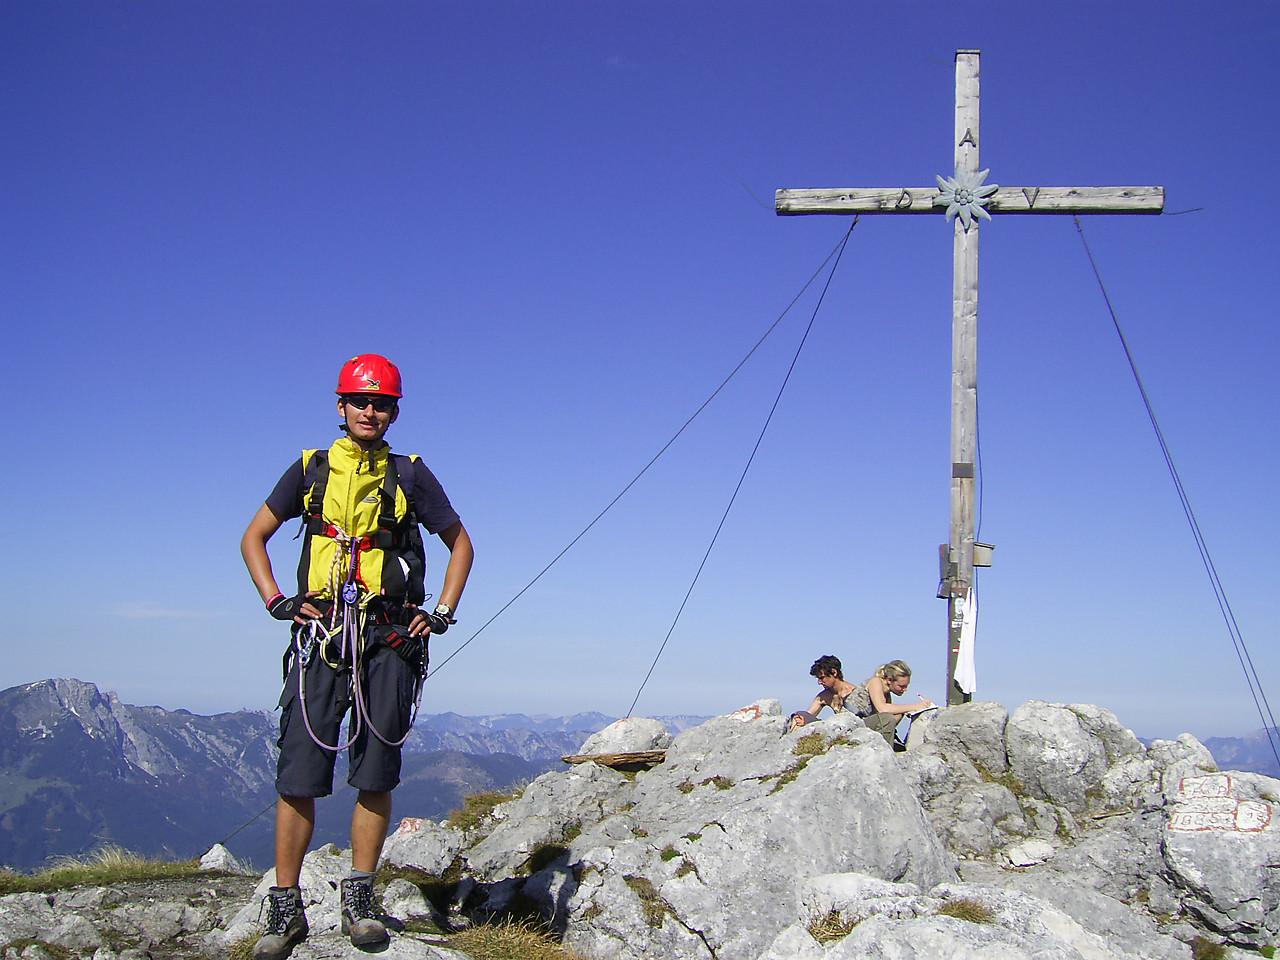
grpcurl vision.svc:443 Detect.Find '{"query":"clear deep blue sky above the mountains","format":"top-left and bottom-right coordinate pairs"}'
top-left (0, 1), bottom-right (1280, 736)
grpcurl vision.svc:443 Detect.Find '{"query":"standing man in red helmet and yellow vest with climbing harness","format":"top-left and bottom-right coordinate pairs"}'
top-left (241, 353), bottom-right (474, 960)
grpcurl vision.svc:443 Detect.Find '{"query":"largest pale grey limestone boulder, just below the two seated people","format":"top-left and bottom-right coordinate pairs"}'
top-left (566, 716), bottom-right (954, 960)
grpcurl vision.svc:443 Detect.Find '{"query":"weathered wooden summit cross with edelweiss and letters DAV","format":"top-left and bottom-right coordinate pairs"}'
top-left (776, 50), bottom-right (1165, 704)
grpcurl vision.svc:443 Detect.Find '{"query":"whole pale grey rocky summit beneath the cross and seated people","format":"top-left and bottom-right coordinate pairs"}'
top-left (0, 700), bottom-right (1280, 960)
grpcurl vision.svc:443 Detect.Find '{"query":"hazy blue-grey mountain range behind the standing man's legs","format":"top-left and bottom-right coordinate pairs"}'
top-left (0, 680), bottom-right (705, 870)
